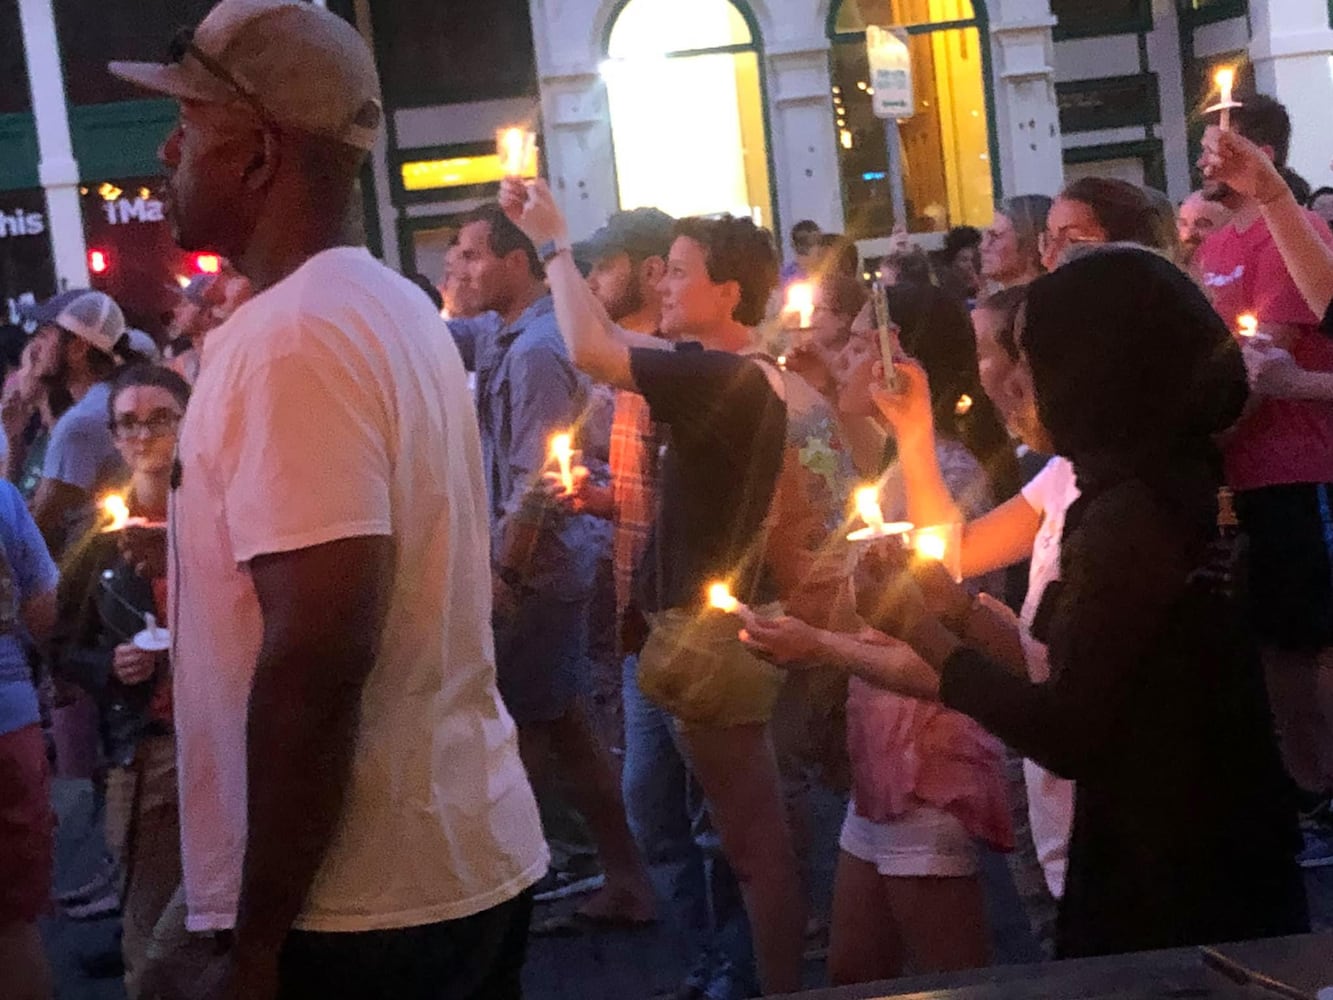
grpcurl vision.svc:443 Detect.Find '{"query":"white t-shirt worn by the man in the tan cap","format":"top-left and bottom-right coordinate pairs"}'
top-left (169, 248), bottom-right (548, 931)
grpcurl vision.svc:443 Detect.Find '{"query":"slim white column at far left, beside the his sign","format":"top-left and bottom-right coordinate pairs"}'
top-left (19, 0), bottom-right (88, 288)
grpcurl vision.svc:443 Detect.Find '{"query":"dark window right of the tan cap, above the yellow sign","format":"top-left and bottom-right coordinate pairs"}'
top-left (371, 0), bottom-right (537, 108)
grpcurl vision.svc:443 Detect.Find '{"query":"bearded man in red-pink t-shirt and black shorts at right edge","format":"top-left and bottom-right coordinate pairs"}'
top-left (1196, 95), bottom-right (1333, 867)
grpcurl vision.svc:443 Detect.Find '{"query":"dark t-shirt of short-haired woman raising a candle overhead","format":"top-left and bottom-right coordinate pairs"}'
top-left (629, 344), bottom-right (786, 611)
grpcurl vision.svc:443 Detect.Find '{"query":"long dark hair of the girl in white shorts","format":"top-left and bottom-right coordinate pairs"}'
top-left (889, 284), bottom-right (1018, 503)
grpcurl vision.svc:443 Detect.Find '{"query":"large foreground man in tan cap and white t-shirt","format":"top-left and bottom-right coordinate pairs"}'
top-left (112, 0), bottom-right (548, 1000)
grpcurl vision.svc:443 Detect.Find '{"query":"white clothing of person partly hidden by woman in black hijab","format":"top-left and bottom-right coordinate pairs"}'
top-left (1021, 456), bottom-right (1078, 899)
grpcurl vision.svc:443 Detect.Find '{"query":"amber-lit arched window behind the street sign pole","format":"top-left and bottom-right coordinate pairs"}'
top-left (832, 0), bottom-right (994, 239)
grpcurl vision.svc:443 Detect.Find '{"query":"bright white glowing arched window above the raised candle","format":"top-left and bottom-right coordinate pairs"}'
top-left (603, 0), bottom-right (773, 225)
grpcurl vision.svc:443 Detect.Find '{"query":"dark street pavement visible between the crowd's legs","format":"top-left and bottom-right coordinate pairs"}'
top-left (38, 780), bottom-right (1333, 1000)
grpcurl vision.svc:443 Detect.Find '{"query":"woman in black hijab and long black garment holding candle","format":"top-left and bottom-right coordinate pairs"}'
top-left (750, 248), bottom-right (1308, 956)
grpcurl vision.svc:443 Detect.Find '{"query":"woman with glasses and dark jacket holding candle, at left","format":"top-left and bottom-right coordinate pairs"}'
top-left (52, 364), bottom-right (189, 997)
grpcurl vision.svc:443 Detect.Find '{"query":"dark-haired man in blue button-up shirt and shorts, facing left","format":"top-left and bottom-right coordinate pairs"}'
top-left (449, 205), bottom-right (655, 924)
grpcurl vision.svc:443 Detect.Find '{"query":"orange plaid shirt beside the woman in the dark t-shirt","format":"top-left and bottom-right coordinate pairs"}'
top-left (611, 392), bottom-right (657, 615)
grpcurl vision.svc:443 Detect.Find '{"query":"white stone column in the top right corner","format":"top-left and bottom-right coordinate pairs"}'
top-left (1250, 0), bottom-right (1333, 188)
